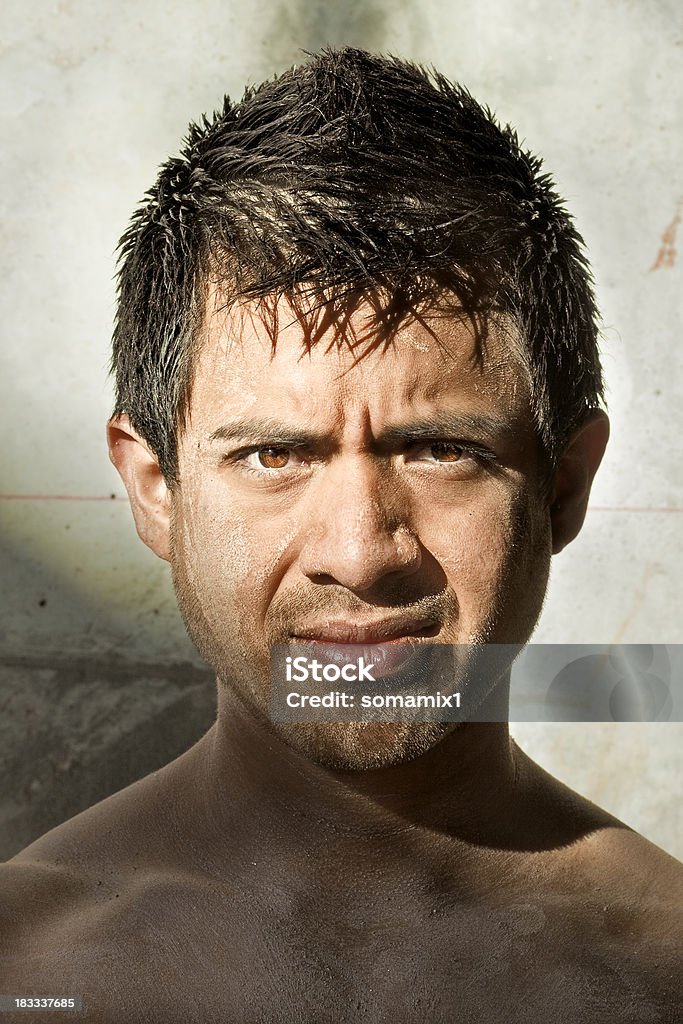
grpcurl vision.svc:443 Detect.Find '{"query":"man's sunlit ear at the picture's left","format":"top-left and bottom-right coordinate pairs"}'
top-left (106, 415), bottom-right (171, 561)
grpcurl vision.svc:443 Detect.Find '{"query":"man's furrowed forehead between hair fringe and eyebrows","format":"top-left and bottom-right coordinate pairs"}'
top-left (189, 294), bottom-right (529, 429)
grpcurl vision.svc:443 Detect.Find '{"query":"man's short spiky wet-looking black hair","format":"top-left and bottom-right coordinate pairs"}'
top-left (112, 48), bottom-right (602, 484)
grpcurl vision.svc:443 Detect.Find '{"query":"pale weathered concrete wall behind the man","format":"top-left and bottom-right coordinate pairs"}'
top-left (0, 0), bottom-right (683, 854)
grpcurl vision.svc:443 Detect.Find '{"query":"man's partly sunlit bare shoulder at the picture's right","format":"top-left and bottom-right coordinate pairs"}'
top-left (511, 761), bottom-right (683, 1007)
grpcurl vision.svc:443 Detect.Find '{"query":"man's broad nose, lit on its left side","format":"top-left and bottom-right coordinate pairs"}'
top-left (299, 456), bottom-right (422, 593)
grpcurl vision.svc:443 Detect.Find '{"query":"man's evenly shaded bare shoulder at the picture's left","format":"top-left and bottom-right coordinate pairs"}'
top-left (0, 769), bottom-right (200, 1022)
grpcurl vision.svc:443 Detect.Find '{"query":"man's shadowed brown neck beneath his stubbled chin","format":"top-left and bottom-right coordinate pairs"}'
top-left (180, 684), bottom-right (519, 864)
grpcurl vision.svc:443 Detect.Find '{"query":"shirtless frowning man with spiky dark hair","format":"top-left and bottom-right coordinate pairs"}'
top-left (0, 50), bottom-right (681, 1024)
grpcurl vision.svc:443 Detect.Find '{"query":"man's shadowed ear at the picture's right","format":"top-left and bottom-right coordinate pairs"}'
top-left (550, 409), bottom-right (609, 555)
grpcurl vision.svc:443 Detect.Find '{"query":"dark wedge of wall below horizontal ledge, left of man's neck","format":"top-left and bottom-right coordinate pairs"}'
top-left (0, 657), bottom-right (216, 860)
